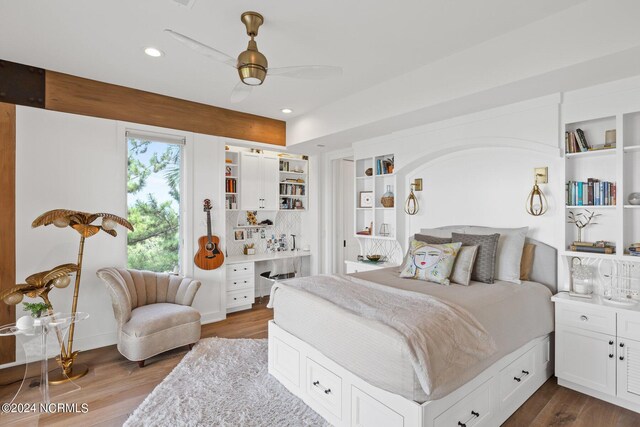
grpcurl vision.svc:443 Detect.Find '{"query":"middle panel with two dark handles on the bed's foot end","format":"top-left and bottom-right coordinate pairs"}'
top-left (306, 358), bottom-right (342, 418)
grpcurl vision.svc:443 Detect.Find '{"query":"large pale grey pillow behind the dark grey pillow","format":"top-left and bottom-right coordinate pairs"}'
top-left (456, 227), bottom-right (529, 284)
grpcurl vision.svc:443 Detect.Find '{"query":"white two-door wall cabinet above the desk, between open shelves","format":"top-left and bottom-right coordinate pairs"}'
top-left (240, 152), bottom-right (279, 211)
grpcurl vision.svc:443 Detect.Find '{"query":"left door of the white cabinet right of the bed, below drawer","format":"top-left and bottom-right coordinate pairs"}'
top-left (556, 325), bottom-right (616, 395)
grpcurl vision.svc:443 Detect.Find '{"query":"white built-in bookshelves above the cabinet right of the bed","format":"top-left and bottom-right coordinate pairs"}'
top-left (560, 112), bottom-right (640, 268)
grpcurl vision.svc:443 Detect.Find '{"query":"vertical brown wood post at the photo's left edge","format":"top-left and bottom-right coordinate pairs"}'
top-left (0, 103), bottom-right (16, 364)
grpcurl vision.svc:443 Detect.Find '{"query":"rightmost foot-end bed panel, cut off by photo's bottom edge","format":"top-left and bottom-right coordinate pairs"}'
top-left (351, 386), bottom-right (404, 427)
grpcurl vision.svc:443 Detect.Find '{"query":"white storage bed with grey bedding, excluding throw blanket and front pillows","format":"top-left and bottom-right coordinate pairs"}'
top-left (269, 239), bottom-right (557, 427)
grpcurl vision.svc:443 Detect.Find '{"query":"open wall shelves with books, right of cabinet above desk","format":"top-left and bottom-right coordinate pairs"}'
top-left (278, 157), bottom-right (309, 211)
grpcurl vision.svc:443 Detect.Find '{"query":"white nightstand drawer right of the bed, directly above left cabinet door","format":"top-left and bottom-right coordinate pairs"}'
top-left (556, 304), bottom-right (616, 335)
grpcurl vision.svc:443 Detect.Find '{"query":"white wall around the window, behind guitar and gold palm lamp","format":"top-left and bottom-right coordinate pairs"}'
top-left (6, 106), bottom-right (226, 368)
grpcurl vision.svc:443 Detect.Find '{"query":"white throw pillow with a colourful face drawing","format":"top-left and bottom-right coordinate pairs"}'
top-left (400, 240), bottom-right (462, 285)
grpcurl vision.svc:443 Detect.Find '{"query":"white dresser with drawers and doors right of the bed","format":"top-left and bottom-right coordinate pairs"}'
top-left (552, 293), bottom-right (640, 412)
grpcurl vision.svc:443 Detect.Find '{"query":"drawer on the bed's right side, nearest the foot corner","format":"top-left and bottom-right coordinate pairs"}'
top-left (433, 380), bottom-right (495, 427)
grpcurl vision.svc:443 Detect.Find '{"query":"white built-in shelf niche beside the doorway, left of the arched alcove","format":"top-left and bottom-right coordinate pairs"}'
top-left (354, 154), bottom-right (397, 240)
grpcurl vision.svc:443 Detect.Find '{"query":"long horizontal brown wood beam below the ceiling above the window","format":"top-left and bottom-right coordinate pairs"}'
top-left (45, 70), bottom-right (286, 146)
